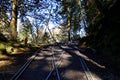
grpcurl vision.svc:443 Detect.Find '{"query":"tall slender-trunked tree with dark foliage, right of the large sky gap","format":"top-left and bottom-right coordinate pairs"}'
top-left (60, 0), bottom-right (80, 43)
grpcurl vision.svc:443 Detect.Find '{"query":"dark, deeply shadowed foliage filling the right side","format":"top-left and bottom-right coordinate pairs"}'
top-left (81, 0), bottom-right (120, 69)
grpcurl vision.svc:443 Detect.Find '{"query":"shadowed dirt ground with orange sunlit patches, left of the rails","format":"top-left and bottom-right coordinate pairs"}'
top-left (0, 47), bottom-right (37, 80)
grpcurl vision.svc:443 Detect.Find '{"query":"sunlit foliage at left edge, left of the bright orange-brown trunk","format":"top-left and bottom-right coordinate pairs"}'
top-left (0, 0), bottom-right (10, 40)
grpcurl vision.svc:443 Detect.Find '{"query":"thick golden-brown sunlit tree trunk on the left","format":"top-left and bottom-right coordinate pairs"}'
top-left (10, 0), bottom-right (18, 40)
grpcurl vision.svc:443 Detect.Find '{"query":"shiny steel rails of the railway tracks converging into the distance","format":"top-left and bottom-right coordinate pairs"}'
top-left (10, 46), bottom-right (94, 80)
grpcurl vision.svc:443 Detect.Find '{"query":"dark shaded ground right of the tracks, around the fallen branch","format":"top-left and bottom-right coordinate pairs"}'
top-left (80, 47), bottom-right (120, 80)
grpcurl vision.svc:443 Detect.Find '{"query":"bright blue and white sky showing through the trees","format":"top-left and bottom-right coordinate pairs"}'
top-left (7, 0), bottom-right (85, 37)
